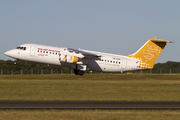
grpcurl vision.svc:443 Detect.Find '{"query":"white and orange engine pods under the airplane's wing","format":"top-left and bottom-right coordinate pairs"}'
top-left (59, 54), bottom-right (78, 63)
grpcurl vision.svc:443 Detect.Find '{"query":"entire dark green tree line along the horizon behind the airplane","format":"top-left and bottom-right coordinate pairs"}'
top-left (0, 60), bottom-right (180, 74)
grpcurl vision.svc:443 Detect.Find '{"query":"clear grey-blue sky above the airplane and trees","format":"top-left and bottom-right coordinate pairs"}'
top-left (0, 0), bottom-right (180, 63)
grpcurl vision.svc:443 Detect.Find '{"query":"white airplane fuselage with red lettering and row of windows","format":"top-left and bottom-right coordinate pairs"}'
top-left (5, 44), bottom-right (140, 72)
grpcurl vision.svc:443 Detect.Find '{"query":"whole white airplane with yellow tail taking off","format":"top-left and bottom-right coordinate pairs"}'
top-left (4, 38), bottom-right (171, 76)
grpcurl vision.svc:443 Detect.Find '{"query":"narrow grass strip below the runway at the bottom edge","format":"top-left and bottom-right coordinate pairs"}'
top-left (0, 110), bottom-right (180, 120)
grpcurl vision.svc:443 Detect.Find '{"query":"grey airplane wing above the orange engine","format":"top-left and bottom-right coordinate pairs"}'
top-left (67, 48), bottom-right (101, 59)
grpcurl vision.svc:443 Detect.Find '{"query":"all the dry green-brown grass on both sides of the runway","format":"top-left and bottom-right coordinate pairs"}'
top-left (0, 74), bottom-right (180, 120)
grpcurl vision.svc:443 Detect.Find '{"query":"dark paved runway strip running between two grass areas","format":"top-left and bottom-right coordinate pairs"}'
top-left (0, 101), bottom-right (180, 110)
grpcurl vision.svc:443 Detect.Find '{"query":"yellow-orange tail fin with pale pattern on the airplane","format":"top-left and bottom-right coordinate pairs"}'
top-left (128, 38), bottom-right (168, 69)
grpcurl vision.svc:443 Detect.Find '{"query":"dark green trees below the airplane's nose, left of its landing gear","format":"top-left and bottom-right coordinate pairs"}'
top-left (0, 60), bottom-right (73, 74)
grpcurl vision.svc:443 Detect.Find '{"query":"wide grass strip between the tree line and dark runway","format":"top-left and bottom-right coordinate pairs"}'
top-left (0, 74), bottom-right (180, 101)
